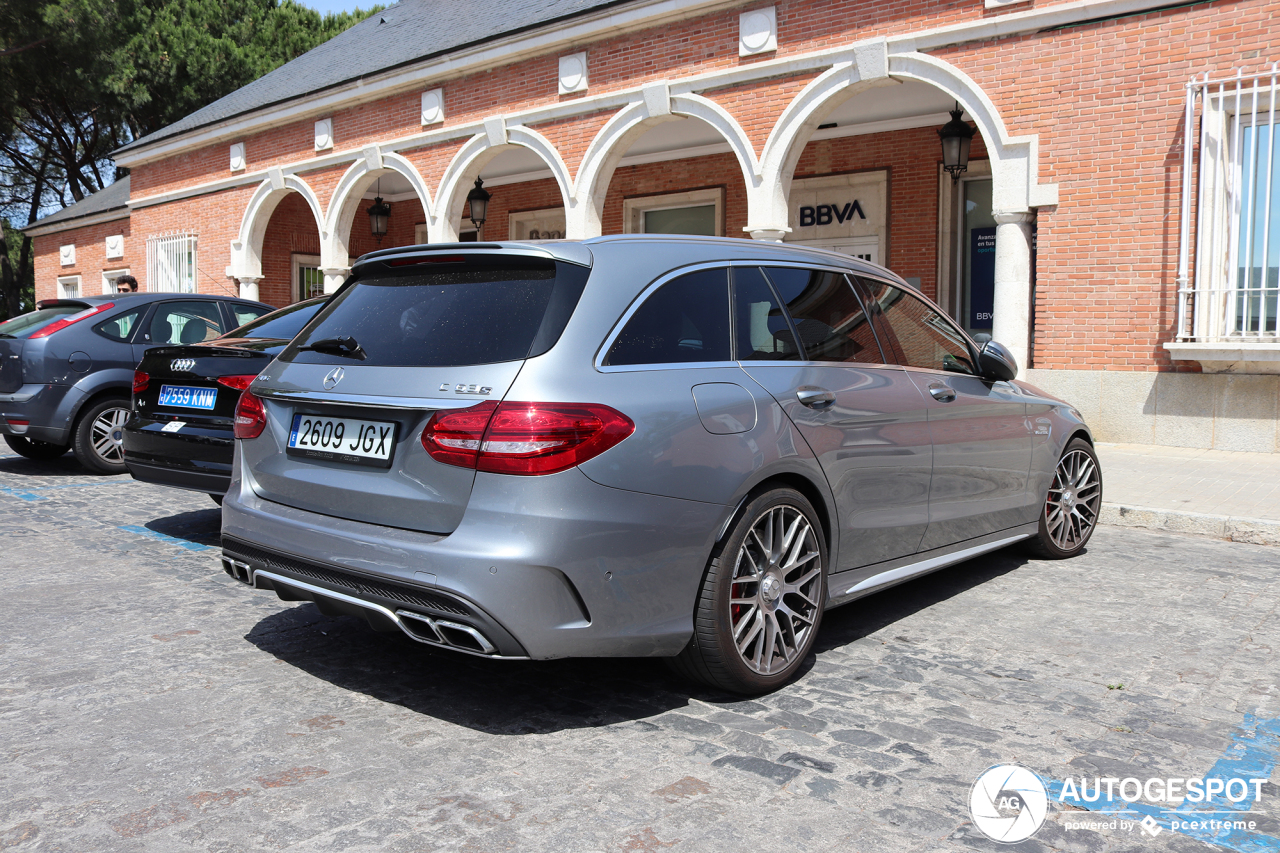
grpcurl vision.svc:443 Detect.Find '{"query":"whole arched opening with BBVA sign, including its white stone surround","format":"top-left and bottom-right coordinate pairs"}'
top-left (760, 49), bottom-right (1057, 368)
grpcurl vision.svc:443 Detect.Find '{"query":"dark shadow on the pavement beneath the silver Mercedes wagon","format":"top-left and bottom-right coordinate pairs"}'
top-left (240, 540), bottom-right (1028, 735)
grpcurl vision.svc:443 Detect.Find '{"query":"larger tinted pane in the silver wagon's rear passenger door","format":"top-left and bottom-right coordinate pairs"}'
top-left (764, 266), bottom-right (884, 364)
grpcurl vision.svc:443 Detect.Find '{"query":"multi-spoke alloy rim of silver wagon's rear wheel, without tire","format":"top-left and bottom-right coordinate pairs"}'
top-left (730, 505), bottom-right (822, 675)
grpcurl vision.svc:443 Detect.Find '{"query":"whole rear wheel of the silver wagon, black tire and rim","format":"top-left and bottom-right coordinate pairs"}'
top-left (672, 488), bottom-right (827, 695)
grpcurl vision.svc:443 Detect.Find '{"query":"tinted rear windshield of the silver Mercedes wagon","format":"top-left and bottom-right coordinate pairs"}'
top-left (280, 255), bottom-right (589, 368)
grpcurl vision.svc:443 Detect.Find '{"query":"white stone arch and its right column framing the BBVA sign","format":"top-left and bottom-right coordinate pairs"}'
top-left (748, 40), bottom-right (1057, 368)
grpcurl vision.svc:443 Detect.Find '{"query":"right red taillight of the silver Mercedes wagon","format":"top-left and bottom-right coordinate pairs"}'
top-left (422, 402), bottom-right (635, 475)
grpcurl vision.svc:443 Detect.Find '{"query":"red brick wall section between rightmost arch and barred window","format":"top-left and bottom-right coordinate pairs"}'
top-left (937, 0), bottom-right (1280, 371)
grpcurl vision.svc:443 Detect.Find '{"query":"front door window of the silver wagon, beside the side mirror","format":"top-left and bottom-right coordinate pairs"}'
top-left (861, 278), bottom-right (977, 374)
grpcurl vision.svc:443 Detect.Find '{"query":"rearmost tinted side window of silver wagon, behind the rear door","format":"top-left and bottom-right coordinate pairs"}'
top-left (604, 269), bottom-right (730, 365)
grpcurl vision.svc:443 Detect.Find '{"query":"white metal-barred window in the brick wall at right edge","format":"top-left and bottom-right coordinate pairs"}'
top-left (1178, 63), bottom-right (1280, 343)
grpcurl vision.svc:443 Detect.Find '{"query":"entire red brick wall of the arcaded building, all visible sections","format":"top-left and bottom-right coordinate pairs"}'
top-left (37, 0), bottom-right (1280, 370)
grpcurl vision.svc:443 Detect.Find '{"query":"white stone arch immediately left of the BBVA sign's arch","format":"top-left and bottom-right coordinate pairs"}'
top-left (566, 83), bottom-right (762, 240)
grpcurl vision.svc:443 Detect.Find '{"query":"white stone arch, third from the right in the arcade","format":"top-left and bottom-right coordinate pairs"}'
top-left (426, 118), bottom-right (572, 243)
